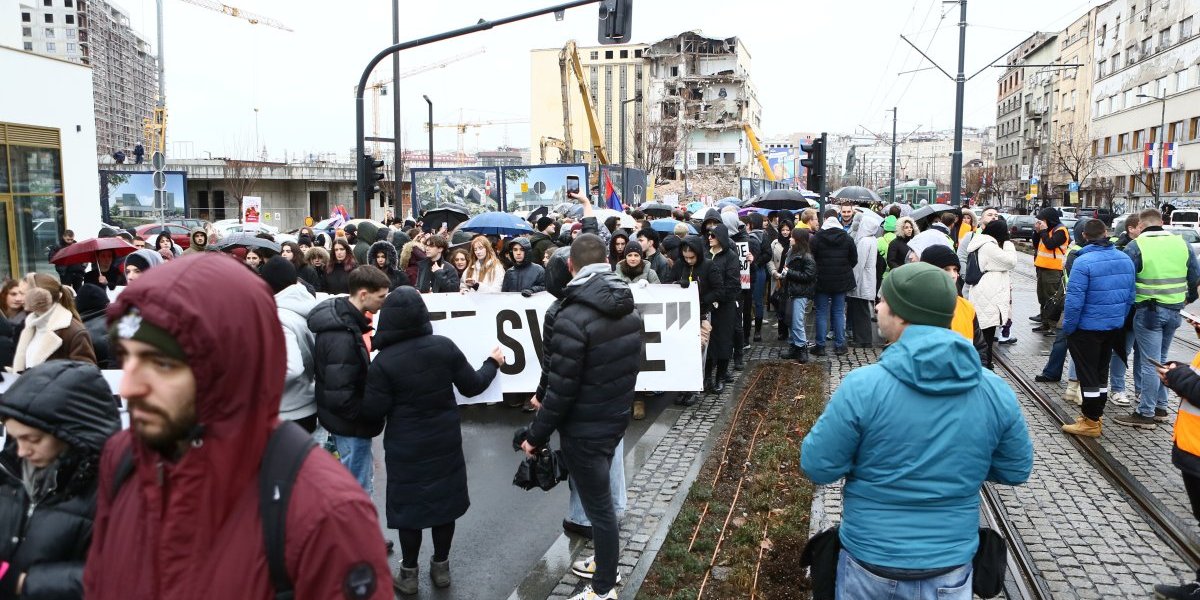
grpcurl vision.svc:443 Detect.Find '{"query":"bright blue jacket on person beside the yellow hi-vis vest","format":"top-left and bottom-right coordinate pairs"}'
top-left (1062, 240), bottom-right (1136, 335)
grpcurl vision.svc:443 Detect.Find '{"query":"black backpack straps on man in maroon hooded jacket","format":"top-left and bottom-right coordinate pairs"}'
top-left (108, 421), bottom-right (317, 600)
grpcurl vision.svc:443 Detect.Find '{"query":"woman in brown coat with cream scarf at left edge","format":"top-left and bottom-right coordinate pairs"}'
top-left (12, 272), bottom-right (96, 373)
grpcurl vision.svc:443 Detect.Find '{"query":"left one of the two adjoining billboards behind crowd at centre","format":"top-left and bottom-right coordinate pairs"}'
top-left (410, 167), bottom-right (500, 215)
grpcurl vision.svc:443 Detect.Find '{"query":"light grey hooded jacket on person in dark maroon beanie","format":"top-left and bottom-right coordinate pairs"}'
top-left (275, 283), bottom-right (318, 421)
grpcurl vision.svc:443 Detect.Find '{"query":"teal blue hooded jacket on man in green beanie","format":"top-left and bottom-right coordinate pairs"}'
top-left (800, 325), bottom-right (1033, 569)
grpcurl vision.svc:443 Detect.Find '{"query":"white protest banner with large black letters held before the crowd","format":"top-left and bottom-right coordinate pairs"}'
top-left (421, 286), bottom-right (703, 404)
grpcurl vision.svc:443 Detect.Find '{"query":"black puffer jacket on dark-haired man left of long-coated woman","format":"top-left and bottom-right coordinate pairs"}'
top-left (308, 298), bottom-right (383, 438)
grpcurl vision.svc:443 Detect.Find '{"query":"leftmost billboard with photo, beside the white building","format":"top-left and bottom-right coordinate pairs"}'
top-left (100, 170), bottom-right (187, 227)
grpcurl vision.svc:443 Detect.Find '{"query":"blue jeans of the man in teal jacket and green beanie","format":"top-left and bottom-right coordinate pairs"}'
top-left (834, 550), bottom-right (973, 600)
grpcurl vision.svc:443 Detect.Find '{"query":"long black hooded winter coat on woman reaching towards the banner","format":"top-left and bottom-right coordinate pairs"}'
top-left (362, 288), bottom-right (498, 529)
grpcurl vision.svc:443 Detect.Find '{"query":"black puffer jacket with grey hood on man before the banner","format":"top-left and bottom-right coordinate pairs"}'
top-left (529, 263), bottom-right (644, 446)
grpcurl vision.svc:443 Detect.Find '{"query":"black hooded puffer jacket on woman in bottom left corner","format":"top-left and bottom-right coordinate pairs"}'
top-left (0, 360), bottom-right (121, 600)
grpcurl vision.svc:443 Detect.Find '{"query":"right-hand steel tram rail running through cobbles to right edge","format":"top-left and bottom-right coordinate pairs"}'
top-left (995, 352), bottom-right (1200, 570)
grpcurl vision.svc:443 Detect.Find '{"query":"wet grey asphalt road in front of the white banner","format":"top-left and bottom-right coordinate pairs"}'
top-left (362, 392), bottom-right (678, 600)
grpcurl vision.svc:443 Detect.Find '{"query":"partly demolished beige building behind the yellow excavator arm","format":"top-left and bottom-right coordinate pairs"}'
top-left (529, 31), bottom-right (763, 196)
